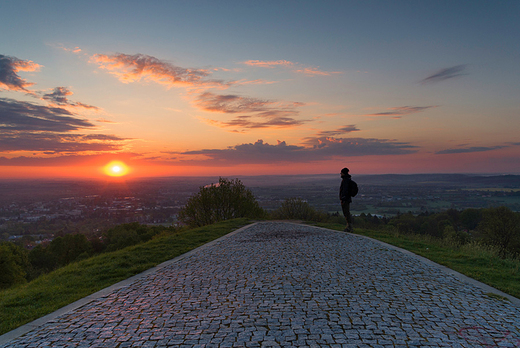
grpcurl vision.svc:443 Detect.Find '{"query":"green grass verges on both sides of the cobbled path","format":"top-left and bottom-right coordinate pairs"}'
top-left (0, 219), bottom-right (520, 334)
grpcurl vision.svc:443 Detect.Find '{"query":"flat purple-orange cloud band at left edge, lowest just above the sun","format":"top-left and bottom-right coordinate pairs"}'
top-left (0, 132), bottom-right (127, 153)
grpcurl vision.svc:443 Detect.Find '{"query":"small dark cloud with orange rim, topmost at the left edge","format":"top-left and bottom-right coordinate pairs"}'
top-left (0, 54), bottom-right (42, 94)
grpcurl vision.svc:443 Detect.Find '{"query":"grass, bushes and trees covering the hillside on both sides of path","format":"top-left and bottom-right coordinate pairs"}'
top-left (0, 178), bottom-right (520, 334)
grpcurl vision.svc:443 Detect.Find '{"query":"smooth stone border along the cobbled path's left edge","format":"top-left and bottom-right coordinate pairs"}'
top-left (0, 222), bottom-right (259, 345)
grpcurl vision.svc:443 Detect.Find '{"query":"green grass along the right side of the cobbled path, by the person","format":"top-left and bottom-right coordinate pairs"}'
top-left (315, 223), bottom-right (520, 298)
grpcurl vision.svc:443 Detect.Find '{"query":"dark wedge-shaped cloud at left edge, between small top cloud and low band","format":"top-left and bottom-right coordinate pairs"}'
top-left (0, 98), bottom-right (94, 132)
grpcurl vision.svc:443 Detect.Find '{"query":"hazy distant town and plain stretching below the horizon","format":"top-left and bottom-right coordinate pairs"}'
top-left (0, 174), bottom-right (520, 245)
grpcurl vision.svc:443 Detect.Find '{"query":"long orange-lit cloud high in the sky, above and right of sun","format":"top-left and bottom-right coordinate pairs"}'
top-left (90, 53), bottom-right (228, 87)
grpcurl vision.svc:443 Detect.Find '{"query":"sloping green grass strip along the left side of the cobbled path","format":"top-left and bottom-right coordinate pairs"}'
top-left (0, 219), bottom-right (249, 335)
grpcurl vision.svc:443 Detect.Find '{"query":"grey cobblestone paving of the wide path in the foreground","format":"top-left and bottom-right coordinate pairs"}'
top-left (2, 222), bottom-right (520, 347)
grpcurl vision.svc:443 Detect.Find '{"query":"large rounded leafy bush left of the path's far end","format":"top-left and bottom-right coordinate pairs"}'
top-left (178, 178), bottom-right (264, 227)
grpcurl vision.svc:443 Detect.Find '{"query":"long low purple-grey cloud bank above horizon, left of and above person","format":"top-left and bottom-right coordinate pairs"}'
top-left (181, 138), bottom-right (416, 165)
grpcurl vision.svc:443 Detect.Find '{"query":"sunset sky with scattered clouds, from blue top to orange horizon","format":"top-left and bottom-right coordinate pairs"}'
top-left (0, 0), bottom-right (520, 178)
